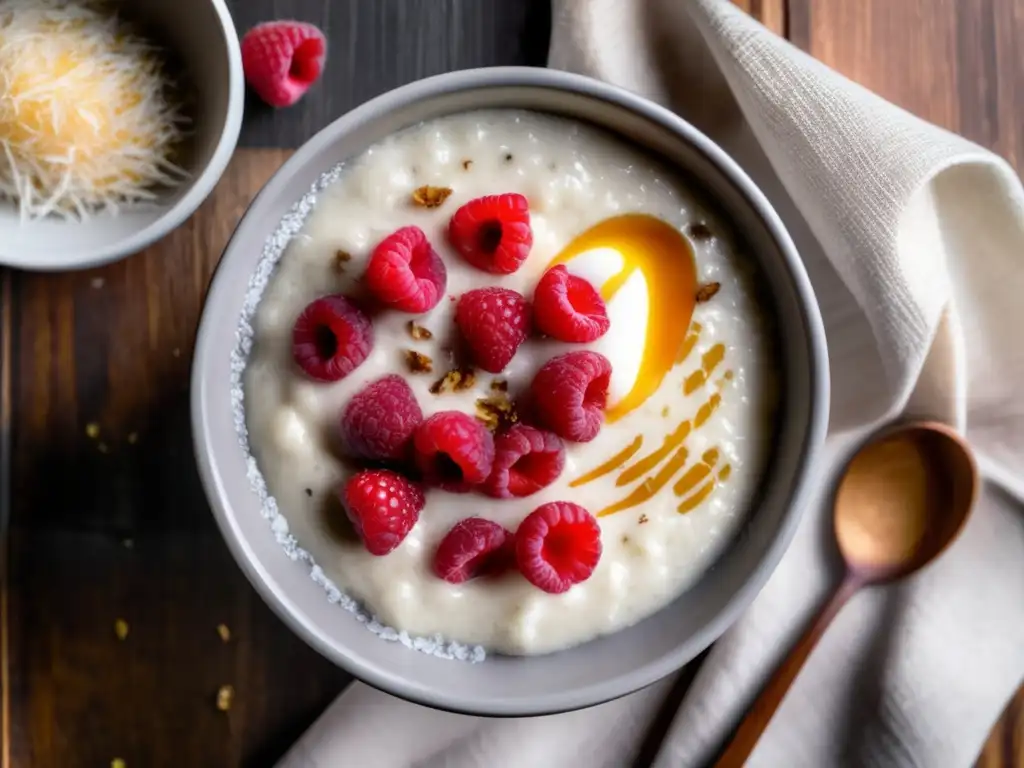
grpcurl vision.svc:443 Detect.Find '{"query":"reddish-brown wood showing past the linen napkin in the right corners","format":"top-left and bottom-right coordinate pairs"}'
top-left (790, 0), bottom-right (1024, 768)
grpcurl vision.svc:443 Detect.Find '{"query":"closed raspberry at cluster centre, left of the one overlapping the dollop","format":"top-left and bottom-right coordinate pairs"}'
top-left (455, 288), bottom-right (530, 374)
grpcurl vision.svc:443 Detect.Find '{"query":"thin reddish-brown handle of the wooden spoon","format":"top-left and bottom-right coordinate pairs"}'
top-left (715, 574), bottom-right (861, 768)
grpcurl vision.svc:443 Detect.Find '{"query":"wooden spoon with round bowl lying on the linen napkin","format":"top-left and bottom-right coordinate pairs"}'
top-left (716, 422), bottom-right (978, 768)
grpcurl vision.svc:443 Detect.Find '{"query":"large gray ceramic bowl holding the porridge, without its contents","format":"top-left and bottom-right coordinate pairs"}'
top-left (193, 69), bottom-right (828, 716)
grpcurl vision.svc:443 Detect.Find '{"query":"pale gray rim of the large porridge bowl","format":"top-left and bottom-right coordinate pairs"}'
top-left (191, 67), bottom-right (830, 717)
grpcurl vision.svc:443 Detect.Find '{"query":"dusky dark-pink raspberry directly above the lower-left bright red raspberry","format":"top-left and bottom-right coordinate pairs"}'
top-left (341, 374), bottom-right (423, 461)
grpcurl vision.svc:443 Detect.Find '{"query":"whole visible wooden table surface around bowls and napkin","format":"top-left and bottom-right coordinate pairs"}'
top-left (0, 0), bottom-right (1024, 768)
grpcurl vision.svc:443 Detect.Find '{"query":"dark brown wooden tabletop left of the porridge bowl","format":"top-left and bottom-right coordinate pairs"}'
top-left (6, 150), bottom-right (364, 766)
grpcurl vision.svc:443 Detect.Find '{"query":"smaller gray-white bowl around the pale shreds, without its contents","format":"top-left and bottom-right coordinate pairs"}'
top-left (0, 0), bottom-right (245, 270)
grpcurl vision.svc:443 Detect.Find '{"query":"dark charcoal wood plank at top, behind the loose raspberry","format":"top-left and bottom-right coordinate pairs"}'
top-left (229, 0), bottom-right (552, 146)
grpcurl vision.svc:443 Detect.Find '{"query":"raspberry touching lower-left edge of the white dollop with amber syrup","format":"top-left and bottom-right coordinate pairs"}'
top-left (530, 351), bottom-right (611, 442)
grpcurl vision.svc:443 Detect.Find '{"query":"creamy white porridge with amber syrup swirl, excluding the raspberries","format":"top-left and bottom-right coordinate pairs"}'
top-left (244, 111), bottom-right (772, 653)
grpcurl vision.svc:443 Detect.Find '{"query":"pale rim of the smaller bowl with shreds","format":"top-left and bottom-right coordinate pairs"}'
top-left (0, 0), bottom-right (246, 272)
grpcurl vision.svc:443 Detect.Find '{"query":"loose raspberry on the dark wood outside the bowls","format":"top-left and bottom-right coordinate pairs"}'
top-left (242, 22), bottom-right (327, 106)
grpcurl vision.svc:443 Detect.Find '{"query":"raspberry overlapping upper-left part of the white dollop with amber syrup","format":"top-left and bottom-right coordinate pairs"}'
top-left (534, 264), bottom-right (611, 342)
